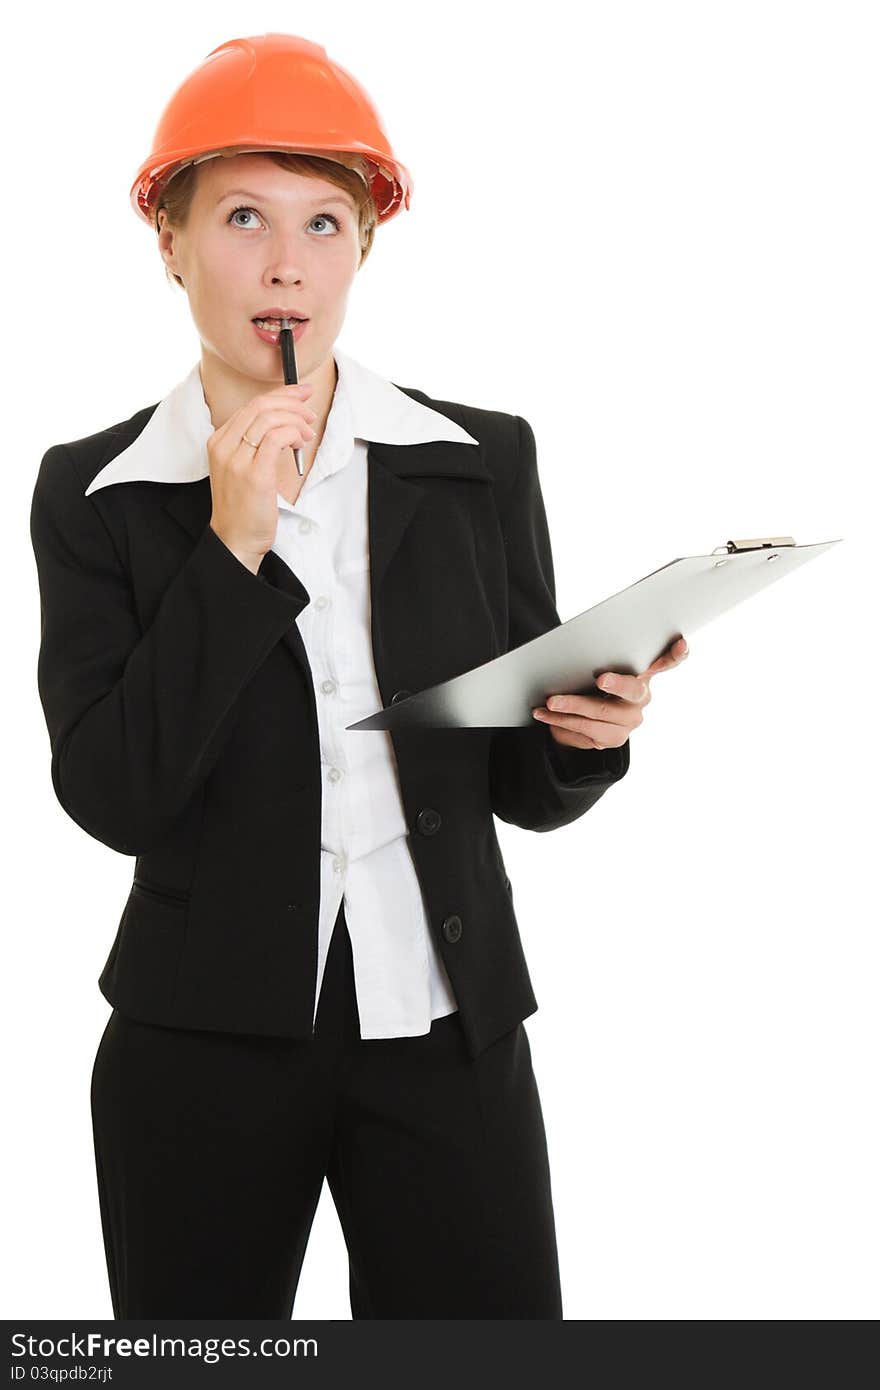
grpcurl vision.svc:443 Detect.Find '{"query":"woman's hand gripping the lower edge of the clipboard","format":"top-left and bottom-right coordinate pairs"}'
top-left (532, 637), bottom-right (688, 748)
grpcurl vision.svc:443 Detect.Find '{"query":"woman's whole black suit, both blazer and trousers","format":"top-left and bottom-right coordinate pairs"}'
top-left (31, 378), bottom-right (630, 1318)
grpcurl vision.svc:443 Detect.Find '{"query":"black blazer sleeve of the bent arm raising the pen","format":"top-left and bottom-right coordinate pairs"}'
top-left (31, 445), bottom-right (299, 855)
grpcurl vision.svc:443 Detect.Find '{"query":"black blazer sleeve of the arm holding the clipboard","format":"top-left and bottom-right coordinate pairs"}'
top-left (489, 405), bottom-right (630, 830)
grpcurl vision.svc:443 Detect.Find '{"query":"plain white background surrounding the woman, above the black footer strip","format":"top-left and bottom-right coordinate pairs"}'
top-left (3, 0), bottom-right (880, 1319)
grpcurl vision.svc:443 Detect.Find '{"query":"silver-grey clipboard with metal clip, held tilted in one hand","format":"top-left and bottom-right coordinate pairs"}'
top-left (346, 537), bottom-right (841, 730)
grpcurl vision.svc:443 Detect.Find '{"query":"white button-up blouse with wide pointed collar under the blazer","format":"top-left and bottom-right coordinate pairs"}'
top-left (86, 348), bottom-right (478, 1038)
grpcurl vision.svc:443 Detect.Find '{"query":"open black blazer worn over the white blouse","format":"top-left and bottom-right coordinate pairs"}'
top-left (31, 388), bottom-right (630, 1056)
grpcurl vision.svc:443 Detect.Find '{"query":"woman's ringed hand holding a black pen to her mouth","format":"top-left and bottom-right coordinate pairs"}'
top-left (207, 381), bottom-right (317, 574)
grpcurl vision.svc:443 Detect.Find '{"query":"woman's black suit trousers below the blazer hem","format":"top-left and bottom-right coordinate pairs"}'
top-left (92, 909), bottom-right (563, 1319)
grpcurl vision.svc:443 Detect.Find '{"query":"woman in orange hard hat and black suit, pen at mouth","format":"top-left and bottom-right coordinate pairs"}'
top-left (32, 35), bottom-right (683, 1318)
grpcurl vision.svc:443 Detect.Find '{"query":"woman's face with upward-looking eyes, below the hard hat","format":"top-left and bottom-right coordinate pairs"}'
top-left (158, 154), bottom-right (360, 425)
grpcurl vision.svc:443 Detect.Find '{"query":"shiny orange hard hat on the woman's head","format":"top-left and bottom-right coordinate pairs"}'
top-left (129, 33), bottom-right (413, 227)
